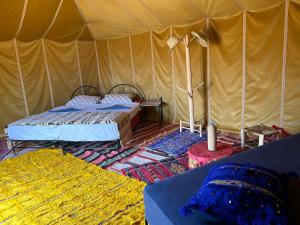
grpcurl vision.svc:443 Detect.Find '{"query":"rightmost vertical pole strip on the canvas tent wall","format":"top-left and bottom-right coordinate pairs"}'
top-left (280, 0), bottom-right (289, 127)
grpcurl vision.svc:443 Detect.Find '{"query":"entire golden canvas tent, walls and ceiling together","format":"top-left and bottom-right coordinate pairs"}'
top-left (0, 0), bottom-right (300, 135)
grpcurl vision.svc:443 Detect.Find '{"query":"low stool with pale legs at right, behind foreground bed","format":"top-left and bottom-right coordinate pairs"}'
top-left (241, 124), bottom-right (281, 146)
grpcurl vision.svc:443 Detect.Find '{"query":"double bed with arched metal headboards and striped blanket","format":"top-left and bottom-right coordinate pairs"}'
top-left (6, 84), bottom-right (144, 154)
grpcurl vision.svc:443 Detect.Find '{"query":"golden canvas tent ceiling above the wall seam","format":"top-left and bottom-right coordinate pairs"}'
top-left (0, 0), bottom-right (288, 42)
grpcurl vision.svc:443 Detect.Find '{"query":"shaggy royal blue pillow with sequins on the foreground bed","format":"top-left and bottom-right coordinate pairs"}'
top-left (179, 163), bottom-right (292, 225)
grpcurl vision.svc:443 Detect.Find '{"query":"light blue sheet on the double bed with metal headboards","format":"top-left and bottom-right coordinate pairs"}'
top-left (7, 103), bottom-right (140, 141)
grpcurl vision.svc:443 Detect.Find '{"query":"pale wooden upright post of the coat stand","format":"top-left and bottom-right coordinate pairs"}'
top-left (184, 34), bottom-right (194, 133)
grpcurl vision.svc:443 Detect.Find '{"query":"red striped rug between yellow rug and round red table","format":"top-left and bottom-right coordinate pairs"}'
top-left (121, 154), bottom-right (189, 183)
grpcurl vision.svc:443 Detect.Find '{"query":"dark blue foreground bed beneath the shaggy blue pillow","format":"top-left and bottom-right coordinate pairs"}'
top-left (144, 134), bottom-right (300, 225)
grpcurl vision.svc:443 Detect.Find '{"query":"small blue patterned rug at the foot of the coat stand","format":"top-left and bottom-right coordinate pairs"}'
top-left (147, 130), bottom-right (206, 156)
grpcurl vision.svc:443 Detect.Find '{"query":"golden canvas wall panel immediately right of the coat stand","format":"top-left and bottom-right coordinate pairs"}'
top-left (210, 13), bottom-right (243, 130)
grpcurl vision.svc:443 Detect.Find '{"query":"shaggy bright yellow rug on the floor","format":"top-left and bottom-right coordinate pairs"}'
top-left (0, 149), bottom-right (145, 225)
